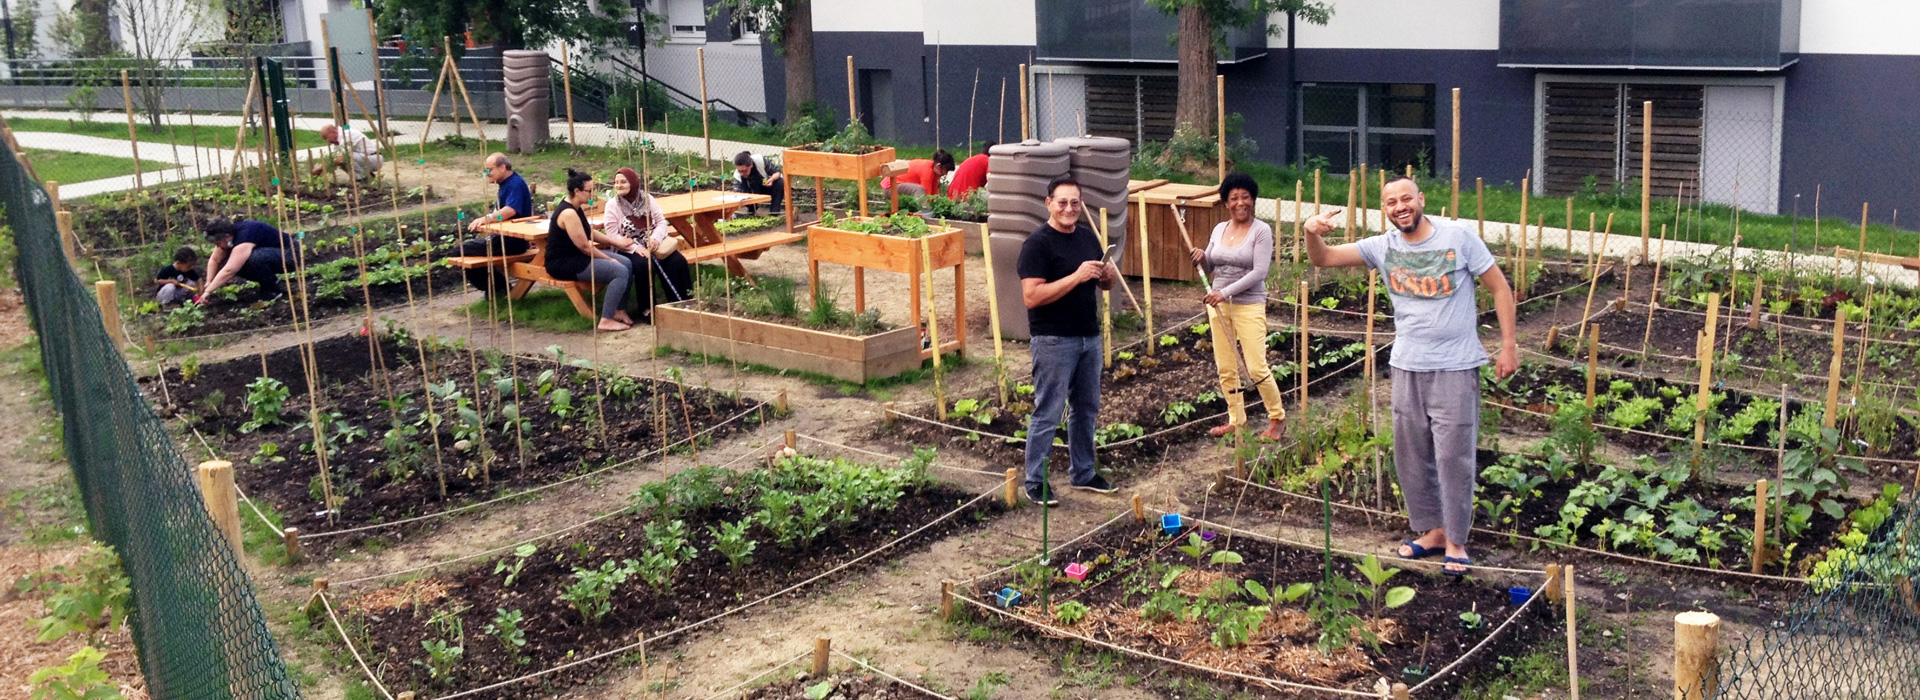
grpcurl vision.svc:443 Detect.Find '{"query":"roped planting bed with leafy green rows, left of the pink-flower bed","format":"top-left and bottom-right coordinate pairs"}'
top-left (326, 451), bottom-right (1000, 698)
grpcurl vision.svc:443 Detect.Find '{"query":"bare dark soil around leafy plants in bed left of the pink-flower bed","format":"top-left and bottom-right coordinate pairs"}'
top-left (346, 485), bottom-right (1004, 698)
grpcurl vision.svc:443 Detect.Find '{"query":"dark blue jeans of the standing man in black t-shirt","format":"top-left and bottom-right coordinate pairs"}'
top-left (1027, 336), bottom-right (1100, 485)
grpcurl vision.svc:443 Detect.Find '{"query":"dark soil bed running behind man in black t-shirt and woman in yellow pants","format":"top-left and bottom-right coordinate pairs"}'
top-left (890, 326), bottom-right (1386, 470)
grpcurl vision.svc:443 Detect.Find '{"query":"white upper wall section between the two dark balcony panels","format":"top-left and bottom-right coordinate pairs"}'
top-left (1267, 0), bottom-right (1500, 52)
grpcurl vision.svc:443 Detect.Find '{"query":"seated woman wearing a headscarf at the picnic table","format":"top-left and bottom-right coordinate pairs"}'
top-left (603, 167), bottom-right (693, 322)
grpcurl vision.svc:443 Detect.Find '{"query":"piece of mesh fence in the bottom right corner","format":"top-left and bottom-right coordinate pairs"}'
top-left (1707, 502), bottom-right (1920, 700)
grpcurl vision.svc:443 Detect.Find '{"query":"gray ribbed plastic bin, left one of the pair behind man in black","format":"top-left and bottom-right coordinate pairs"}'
top-left (987, 140), bottom-right (1071, 339)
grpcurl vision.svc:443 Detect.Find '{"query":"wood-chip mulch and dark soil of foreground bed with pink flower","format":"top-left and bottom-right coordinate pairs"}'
top-left (975, 524), bottom-right (1551, 690)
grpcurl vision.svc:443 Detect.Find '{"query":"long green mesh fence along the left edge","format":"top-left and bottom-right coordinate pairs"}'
top-left (0, 135), bottom-right (300, 700)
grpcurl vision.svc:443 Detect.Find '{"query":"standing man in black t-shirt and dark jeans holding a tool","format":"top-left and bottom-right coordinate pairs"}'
top-left (1016, 176), bottom-right (1119, 506)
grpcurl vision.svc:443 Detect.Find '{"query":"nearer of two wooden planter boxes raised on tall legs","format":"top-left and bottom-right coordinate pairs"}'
top-left (806, 217), bottom-right (966, 357)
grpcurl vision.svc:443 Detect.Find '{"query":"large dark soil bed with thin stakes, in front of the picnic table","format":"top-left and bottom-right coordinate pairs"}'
top-left (142, 336), bottom-right (760, 554)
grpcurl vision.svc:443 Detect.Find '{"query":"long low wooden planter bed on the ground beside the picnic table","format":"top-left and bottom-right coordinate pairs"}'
top-left (653, 301), bottom-right (920, 384)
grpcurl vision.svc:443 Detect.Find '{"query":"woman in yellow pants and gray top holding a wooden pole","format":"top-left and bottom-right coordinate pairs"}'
top-left (1192, 173), bottom-right (1286, 439)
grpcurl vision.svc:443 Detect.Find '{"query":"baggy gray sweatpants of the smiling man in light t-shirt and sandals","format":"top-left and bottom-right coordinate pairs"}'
top-left (1394, 368), bottom-right (1480, 545)
